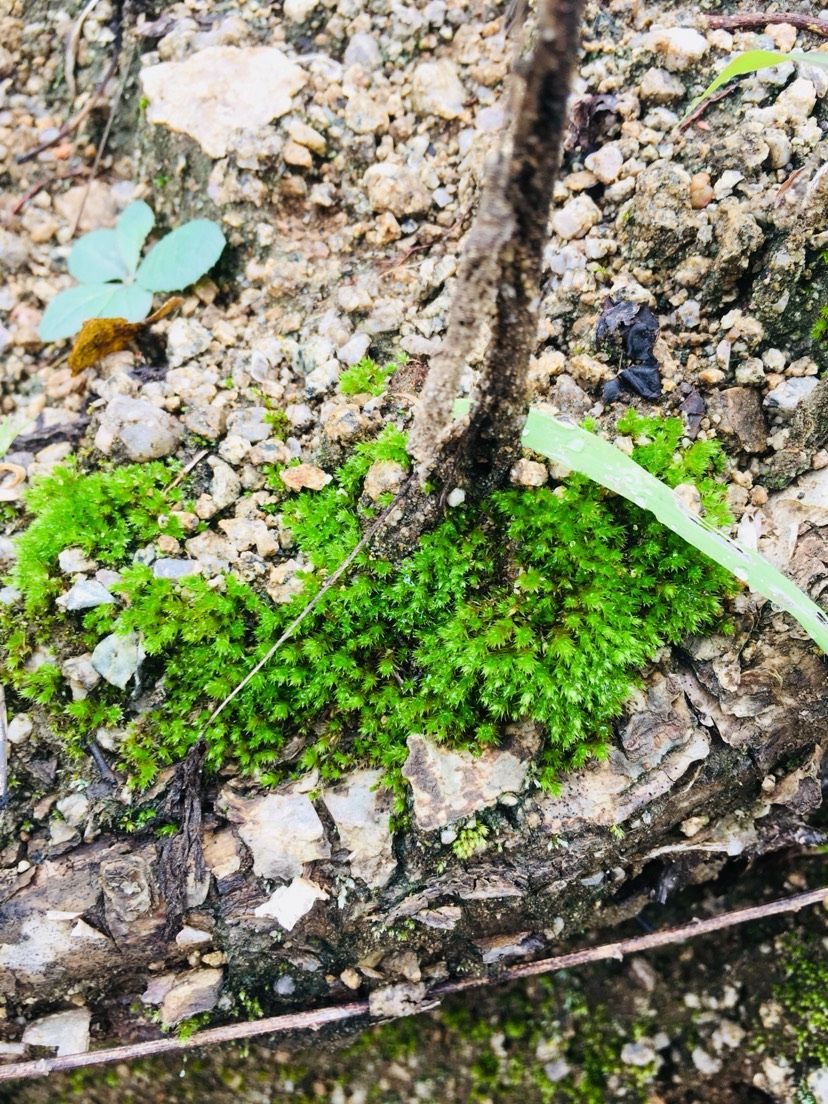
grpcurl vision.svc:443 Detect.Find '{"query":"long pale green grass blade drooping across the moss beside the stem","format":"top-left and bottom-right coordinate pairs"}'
top-left (523, 410), bottom-right (828, 652)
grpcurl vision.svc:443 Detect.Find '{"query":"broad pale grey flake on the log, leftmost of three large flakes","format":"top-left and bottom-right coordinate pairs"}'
top-left (221, 788), bottom-right (330, 881)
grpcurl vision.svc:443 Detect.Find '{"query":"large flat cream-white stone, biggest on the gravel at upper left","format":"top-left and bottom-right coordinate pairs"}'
top-left (141, 47), bottom-right (307, 158)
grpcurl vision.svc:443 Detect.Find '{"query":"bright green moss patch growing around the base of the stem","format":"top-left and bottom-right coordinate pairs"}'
top-left (0, 415), bottom-right (735, 786)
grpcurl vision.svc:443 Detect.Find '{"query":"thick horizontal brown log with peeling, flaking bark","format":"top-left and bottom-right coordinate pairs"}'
top-left (0, 574), bottom-right (828, 1055)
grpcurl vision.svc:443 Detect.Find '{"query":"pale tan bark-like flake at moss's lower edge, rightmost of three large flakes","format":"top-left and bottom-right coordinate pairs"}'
top-left (403, 735), bottom-right (531, 831)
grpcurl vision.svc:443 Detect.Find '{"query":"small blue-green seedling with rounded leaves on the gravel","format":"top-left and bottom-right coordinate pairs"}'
top-left (40, 200), bottom-right (225, 341)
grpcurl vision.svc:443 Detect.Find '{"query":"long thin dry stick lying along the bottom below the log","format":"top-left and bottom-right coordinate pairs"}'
top-left (0, 887), bottom-right (828, 1081)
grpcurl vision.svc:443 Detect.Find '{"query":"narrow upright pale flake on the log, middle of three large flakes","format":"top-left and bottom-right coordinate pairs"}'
top-left (322, 771), bottom-right (396, 887)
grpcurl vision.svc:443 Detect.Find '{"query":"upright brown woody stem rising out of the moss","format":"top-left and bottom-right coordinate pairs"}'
top-left (406, 0), bottom-right (583, 496)
